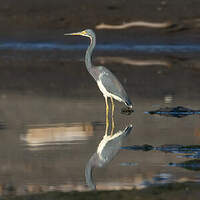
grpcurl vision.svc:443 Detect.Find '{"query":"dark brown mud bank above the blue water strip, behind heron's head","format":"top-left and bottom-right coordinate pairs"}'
top-left (0, 0), bottom-right (200, 43)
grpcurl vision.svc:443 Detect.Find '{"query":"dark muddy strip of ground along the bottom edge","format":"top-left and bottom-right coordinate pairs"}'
top-left (2, 183), bottom-right (200, 200)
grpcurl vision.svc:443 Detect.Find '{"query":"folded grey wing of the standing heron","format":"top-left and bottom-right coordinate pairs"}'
top-left (98, 66), bottom-right (129, 101)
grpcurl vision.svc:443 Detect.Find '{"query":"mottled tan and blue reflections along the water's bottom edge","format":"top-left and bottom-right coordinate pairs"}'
top-left (0, 173), bottom-right (196, 196)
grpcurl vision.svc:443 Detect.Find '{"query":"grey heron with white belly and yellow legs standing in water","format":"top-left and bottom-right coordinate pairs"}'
top-left (64, 29), bottom-right (132, 132)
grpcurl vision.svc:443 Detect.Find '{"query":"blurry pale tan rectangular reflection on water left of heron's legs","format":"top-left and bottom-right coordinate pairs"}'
top-left (20, 123), bottom-right (93, 150)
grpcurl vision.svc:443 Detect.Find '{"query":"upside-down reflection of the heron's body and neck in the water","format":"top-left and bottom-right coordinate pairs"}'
top-left (85, 121), bottom-right (133, 190)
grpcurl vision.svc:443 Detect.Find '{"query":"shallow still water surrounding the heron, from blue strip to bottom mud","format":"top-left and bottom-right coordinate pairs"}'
top-left (0, 40), bottom-right (200, 194)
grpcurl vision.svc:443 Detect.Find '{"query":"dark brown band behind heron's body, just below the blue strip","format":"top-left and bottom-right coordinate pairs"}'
top-left (0, 50), bottom-right (200, 100)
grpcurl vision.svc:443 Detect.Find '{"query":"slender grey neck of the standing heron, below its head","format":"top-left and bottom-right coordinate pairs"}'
top-left (85, 36), bottom-right (96, 72)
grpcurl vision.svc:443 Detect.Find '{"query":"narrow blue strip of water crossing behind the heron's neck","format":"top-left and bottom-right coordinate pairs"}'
top-left (0, 42), bottom-right (200, 53)
